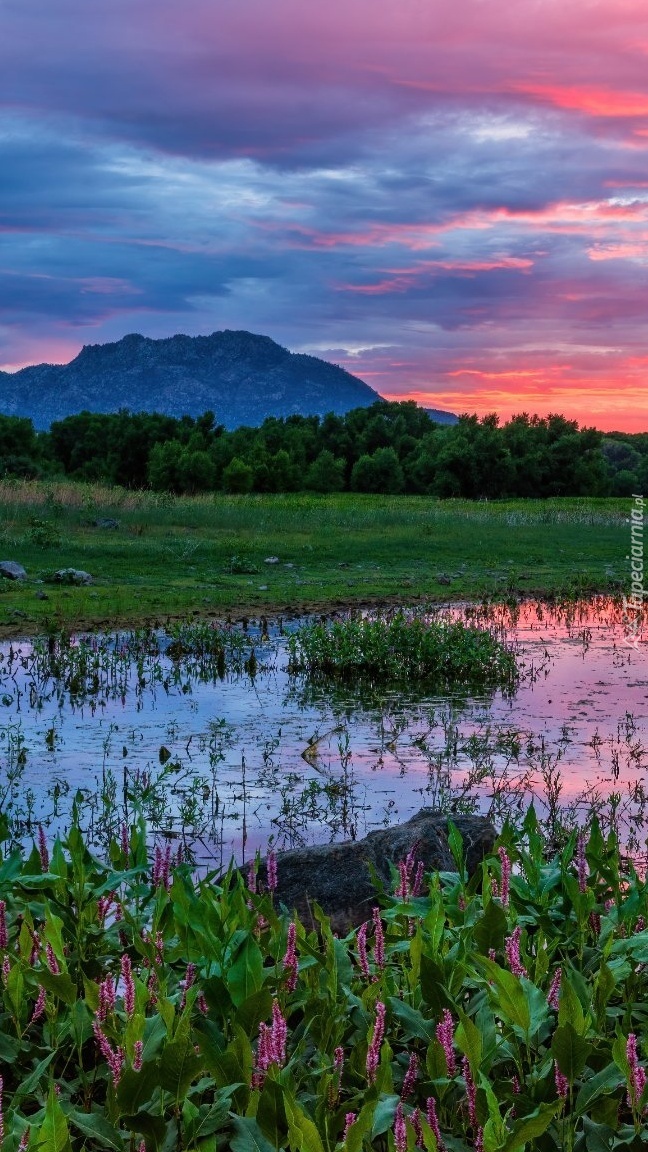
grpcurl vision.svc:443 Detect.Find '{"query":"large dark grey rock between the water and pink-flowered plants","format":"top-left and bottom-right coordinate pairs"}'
top-left (250, 808), bottom-right (497, 933)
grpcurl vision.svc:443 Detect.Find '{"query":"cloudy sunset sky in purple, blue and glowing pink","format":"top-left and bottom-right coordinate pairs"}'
top-left (0, 0), bottom-right (648, 431)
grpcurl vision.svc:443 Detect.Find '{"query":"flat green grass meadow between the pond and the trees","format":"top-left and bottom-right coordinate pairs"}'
top-left (0, 482), bottom-right (628, 635)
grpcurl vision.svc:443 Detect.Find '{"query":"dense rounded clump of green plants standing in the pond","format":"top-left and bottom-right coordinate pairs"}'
top-left (288, 613), bottom-right (518, 690)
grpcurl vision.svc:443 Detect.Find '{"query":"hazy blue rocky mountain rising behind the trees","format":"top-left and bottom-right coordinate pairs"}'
top-left (0, 331), bottom-right (455, 429)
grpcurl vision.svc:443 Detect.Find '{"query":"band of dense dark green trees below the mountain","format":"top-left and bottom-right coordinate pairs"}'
top-left (0, 401), bottom-right (648, 499)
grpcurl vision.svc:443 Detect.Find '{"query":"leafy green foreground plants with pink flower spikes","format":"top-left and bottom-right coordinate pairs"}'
top-left (0, 810), bottom-right (648, 1152)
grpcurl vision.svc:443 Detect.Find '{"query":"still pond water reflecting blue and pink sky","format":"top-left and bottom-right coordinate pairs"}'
top-left (0, 598), bottom-right (648, 864)
